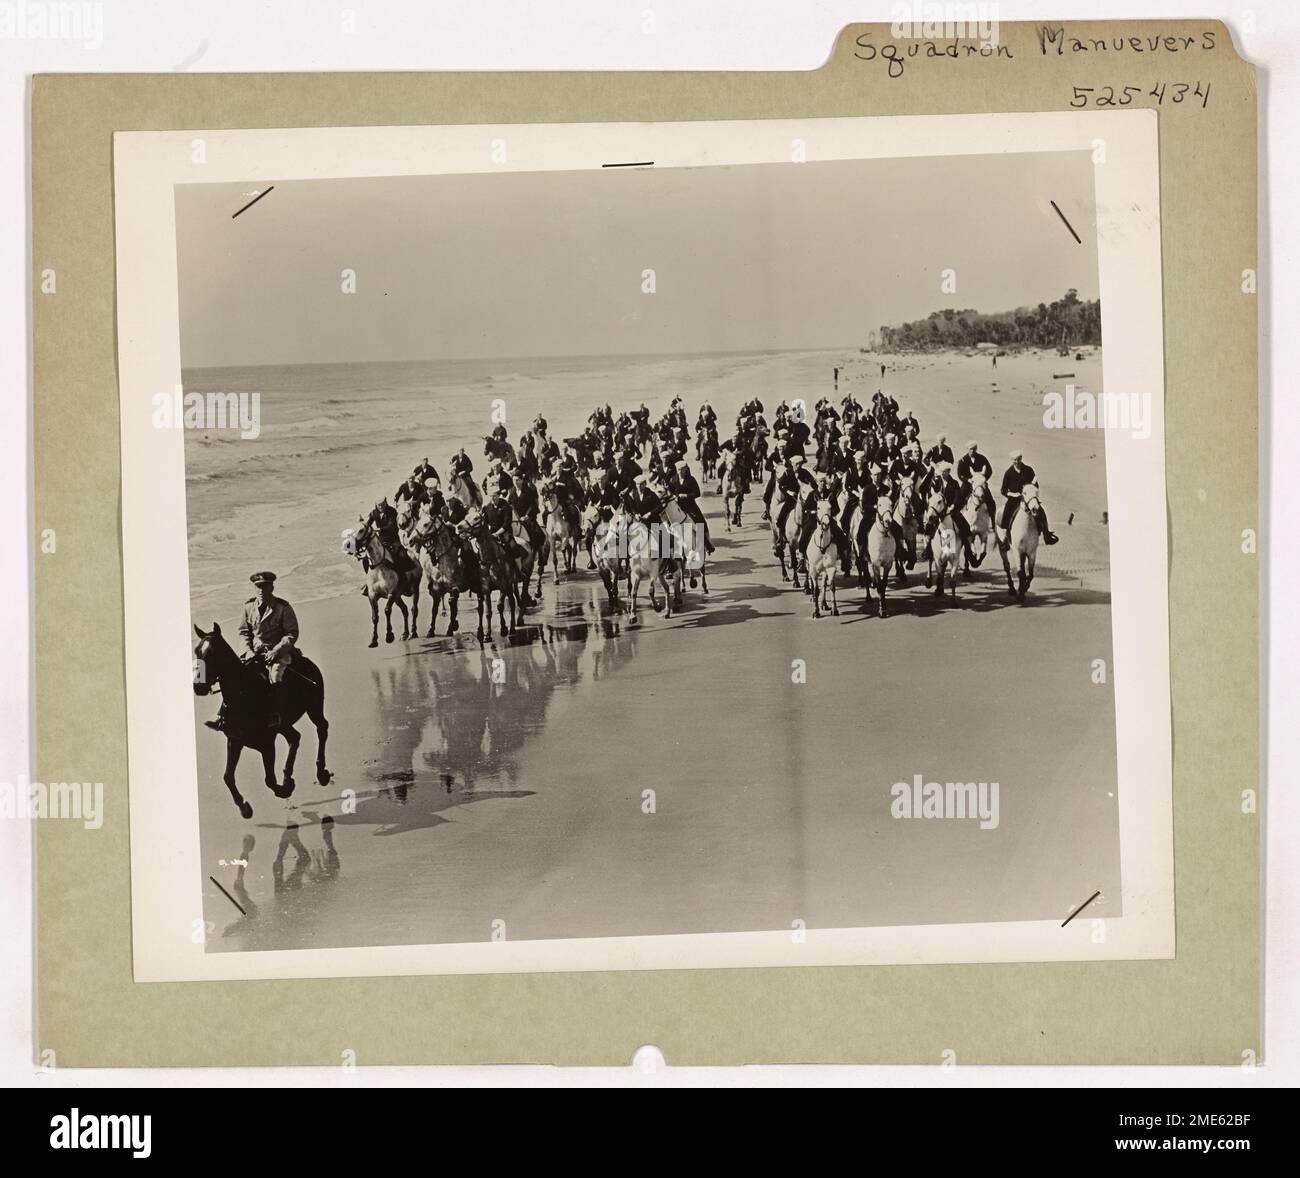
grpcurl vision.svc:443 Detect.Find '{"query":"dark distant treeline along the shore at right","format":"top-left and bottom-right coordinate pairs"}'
top-left (876, 289), bottom-right (1101, 352)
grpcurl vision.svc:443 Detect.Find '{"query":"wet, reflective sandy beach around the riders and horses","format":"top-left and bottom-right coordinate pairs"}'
top-left (189, 350), bottom-right (1119, 952)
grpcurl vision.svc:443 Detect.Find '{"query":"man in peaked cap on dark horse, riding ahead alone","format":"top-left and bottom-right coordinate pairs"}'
top-left (194, 572), bottom-right (330, 818)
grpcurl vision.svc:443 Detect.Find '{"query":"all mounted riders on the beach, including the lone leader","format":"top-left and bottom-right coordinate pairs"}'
top-left (194, 379), bottom-right (1057, 818)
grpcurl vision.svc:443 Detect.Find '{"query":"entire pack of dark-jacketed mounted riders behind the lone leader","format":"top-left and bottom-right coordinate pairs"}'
top-left (348, 379), bottom-right (1057, 646)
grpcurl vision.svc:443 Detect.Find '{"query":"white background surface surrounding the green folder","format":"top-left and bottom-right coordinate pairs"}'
top-left (0, 0), bottom-right (1300, 1088)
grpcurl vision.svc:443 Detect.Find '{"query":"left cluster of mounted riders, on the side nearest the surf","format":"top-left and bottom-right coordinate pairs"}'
top-left (345, 398), bottom-right (714, 646)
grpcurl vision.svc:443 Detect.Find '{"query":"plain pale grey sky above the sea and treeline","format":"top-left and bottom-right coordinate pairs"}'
top-left (176, 152), bottom-right (1099, 368)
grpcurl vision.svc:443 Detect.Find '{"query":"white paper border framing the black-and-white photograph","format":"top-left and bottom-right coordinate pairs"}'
top-left (113, 111), bottom-right (1174, 982)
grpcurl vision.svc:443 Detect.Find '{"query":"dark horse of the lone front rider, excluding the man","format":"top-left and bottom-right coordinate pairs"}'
top-left (194, 623), bottom-right (333, 818)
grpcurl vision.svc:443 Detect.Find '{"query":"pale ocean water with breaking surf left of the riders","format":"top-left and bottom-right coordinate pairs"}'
top-left (183, 350), bottom-right (821, 620)
